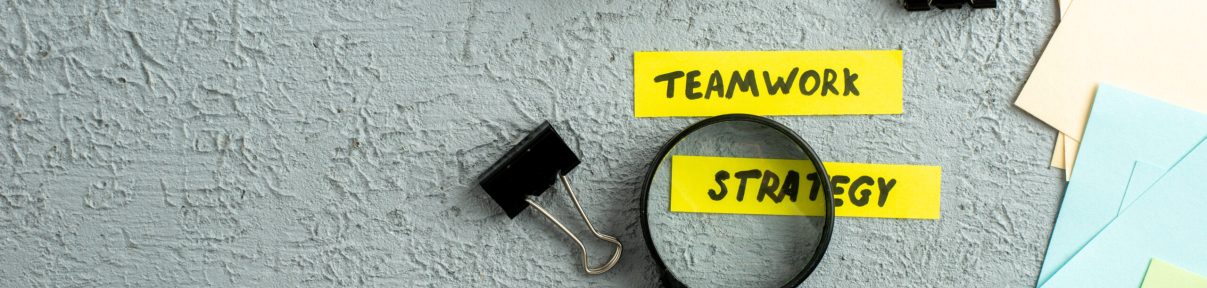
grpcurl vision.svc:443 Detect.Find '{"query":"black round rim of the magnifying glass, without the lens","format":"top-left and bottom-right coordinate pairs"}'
top-left (641, 114), bottom-right (834, 288)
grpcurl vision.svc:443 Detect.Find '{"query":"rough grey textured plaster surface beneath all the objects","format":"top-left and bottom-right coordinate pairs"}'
top-left (0, 0), bottom-right (1063, 287)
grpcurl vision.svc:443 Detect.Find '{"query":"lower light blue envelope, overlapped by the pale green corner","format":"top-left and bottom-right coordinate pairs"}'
top-left (1044, 139), bottom-right (1207, 288)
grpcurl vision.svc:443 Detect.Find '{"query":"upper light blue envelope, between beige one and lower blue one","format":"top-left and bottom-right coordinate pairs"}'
top-left (1037, 84), bottom-right (1207, 286)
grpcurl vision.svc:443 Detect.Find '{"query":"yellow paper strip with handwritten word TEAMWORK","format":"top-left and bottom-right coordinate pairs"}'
top-left (632, 51), bottom-right (904, 117)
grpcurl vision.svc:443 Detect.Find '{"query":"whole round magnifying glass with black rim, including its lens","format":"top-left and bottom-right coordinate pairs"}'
top-left (641, 114), bottom-right (834, 287)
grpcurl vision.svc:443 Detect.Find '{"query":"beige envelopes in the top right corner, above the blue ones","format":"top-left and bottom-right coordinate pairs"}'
top-left (1015, 0), bottom-right (1207, 142)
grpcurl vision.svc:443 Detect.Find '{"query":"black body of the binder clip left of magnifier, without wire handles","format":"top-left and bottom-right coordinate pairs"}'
top-left (478, 121), bottom-right (581, 218)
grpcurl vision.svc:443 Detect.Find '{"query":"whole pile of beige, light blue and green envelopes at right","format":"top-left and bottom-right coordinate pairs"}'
top-left (1015, 0), bottom-right (1207, 283)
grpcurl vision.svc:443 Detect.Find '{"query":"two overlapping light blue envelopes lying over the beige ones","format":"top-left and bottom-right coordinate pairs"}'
top-left (1037, 84), bottom-right (1207, 287)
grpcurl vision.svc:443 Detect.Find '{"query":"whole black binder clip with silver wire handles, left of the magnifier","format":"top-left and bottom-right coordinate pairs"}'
top-left (478, 122), bottom-right (622, 275)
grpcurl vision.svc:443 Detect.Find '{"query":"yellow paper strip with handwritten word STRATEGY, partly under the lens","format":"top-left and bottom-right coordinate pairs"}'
top-left (670, 155), bottom-right (941, 219)
